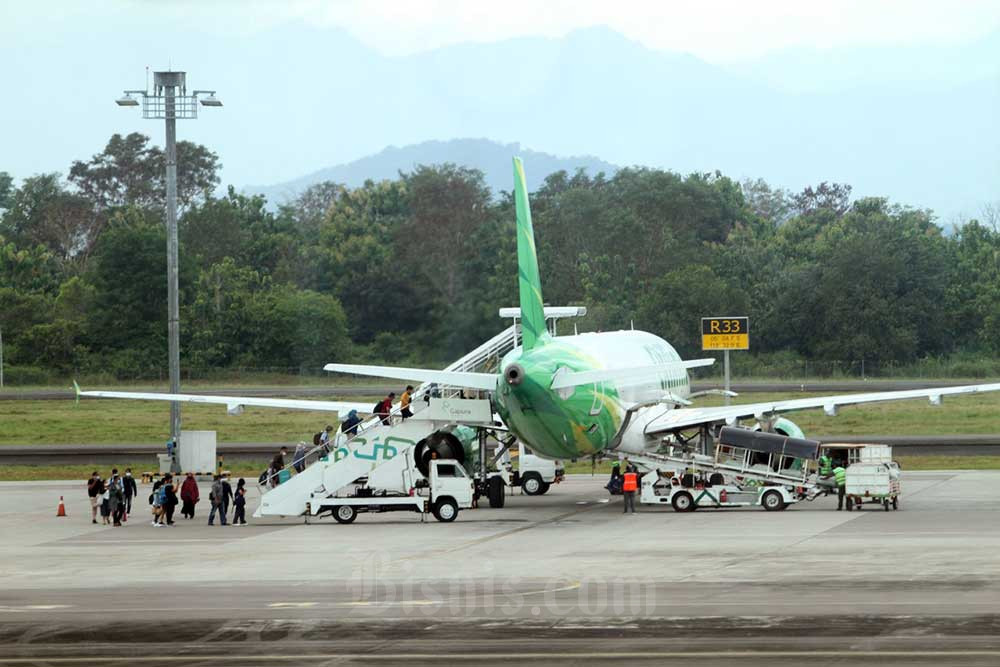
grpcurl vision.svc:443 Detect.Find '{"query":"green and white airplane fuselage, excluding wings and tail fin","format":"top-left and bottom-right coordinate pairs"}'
top-left (496, 331), bottom-right (691, 459)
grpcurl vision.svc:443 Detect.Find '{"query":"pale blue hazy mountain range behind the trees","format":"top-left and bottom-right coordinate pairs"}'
top-left (0, 20), bottom-right (1000, 220)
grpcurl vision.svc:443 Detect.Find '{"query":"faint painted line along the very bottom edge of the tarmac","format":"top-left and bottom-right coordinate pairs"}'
top-left (0, 649), bottom-right (1000, 665)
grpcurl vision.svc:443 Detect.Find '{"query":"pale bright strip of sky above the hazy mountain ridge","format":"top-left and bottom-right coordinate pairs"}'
top-left (0, 0), bottom-right (1000, 63)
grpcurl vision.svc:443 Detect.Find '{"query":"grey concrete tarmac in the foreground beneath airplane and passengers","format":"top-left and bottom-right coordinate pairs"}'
top-left (0, 471), bottom-right (1000, 667)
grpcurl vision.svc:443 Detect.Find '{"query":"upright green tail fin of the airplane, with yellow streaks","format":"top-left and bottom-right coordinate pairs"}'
top-left (514, 158), bottom-right (547, 350)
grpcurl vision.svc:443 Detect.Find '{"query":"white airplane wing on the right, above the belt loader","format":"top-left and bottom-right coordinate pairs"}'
top-left (646, 383), bottom-right (1000, 434)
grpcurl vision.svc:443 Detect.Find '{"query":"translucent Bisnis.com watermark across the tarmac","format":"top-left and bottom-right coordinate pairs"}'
top-left (344, 554), bottom-right (657, 618)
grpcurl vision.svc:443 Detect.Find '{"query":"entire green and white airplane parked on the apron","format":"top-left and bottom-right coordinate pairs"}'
top-left (80, 158), bottom-right (1000, 459)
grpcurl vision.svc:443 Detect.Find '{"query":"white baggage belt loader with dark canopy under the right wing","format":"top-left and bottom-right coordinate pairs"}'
top-left (629, 427), bottom-right (825, 512)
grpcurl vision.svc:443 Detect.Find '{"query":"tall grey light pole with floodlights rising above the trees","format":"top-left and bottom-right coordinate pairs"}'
top-left (115, 72), bottom-right (222, 454)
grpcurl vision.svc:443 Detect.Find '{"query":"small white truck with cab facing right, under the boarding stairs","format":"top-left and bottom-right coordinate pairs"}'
top-left (307, 459), bottom-right (474, 523)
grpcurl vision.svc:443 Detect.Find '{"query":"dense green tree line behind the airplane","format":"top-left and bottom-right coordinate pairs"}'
top-left (0, 134), bottom-right (1000, 376)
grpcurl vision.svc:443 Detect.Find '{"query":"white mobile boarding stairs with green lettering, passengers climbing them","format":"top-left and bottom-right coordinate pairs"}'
top-left (254, 325), bottom-right (518, 518)
